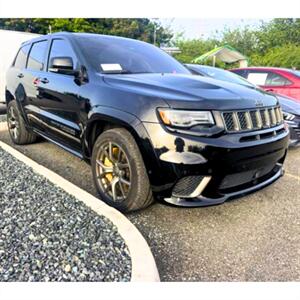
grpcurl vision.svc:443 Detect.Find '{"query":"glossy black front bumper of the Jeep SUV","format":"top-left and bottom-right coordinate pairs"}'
top-left (144, 123), bottom-right (289, 206)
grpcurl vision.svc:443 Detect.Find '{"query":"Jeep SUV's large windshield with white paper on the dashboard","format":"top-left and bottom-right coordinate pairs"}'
top-left (77, 35), bottom-right (191, 74)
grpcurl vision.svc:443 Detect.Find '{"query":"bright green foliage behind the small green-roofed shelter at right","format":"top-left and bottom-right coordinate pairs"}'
top-left (176, 19), bottom-right (300, 69)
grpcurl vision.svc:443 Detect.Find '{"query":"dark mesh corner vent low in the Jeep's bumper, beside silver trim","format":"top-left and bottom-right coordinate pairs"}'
top-left (172, 176), bottom-right (203, 198)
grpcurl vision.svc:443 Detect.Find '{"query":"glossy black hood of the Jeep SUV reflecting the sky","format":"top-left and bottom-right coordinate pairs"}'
top-left (103, 74), bottom-right (277, 110)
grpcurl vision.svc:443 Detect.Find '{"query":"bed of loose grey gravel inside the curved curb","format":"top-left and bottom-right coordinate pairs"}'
top-left (0, 148), bottom-right (131, 281)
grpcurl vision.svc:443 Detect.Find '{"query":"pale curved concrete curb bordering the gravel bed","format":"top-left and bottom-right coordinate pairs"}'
top-left (0, 140), bottom-right (160, 282)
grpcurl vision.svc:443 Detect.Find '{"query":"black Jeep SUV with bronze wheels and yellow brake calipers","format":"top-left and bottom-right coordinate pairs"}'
top-left (6, 33), bottom-right (289, 211)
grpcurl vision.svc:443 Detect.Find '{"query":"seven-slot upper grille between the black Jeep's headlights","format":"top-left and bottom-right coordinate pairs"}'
top-left (222, 107), bottom-right (283, 132)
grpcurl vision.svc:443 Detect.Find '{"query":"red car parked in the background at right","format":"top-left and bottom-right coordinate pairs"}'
top-left (230, 67), bottom-right (300, 101)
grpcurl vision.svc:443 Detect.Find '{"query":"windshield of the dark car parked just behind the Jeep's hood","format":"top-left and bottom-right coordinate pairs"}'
top-left (195, 66), bottom-right (255, 87)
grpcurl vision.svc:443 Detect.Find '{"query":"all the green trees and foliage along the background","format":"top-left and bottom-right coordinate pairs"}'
top-left (0, 18), bottom-right (300, 68)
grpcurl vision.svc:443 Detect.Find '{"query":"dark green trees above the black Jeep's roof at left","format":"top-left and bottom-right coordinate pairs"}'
top-left (0, 18), bottom-right (173, 44)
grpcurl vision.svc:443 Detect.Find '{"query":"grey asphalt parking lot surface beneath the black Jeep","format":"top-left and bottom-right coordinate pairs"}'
top-left (0, 115), bottom-right (300, 281)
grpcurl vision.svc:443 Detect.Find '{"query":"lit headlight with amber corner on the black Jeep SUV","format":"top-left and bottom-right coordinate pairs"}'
top-left (158, 109), bottom-right (215, 128)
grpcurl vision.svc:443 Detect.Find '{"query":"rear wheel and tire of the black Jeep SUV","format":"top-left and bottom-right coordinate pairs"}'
top-left (7, 100), bottom-right (36, 145)
